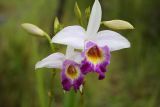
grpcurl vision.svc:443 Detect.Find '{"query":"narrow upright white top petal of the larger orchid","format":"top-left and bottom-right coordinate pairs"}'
top-left (87, 0), bottom-right (102, 37)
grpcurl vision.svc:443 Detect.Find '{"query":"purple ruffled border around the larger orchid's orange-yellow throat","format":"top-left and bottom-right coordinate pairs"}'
top-left (81, 41), bottom-right (111, 80)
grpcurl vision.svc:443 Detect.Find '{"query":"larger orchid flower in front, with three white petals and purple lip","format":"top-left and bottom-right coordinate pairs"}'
top-left (52, 0), bottom-right (130, 79)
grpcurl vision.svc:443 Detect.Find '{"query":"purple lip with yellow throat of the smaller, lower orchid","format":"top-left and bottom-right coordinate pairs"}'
top-left (61, 60), bottom-right (84, 91)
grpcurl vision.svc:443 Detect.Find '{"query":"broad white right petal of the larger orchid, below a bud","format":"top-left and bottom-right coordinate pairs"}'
top-left (94, 30), bottom-right (130, 51)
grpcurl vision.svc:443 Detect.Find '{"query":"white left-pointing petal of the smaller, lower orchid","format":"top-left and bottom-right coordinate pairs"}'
top-left (35, 53), bottom-right (65, 69)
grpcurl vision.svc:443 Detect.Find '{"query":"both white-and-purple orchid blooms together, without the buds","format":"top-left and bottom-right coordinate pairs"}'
top-left (33, 0), bottom-right (130, 91)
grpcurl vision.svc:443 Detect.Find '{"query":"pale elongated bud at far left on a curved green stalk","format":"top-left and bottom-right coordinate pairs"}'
top-left (21, 23), bottom-right (45, 36)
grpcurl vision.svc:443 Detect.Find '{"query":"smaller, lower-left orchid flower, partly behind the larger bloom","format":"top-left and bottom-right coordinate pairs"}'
top-left (35, 46), bottom-right (84, 91)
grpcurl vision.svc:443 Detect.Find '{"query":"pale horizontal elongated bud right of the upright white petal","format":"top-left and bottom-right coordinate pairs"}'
top-left (102, 20), bottom-right (134, 30)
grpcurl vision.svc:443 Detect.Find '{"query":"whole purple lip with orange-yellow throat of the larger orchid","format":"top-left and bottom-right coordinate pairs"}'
top-left (81, 41), bottom-right (111, 80)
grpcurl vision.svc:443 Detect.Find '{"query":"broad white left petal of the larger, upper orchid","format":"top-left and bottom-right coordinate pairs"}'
top-left (52, 26), bottom-right (85, 49)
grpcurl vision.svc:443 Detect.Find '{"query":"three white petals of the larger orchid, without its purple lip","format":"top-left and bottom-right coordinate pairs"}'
top-left (52, 0), bottom-right (130, 51)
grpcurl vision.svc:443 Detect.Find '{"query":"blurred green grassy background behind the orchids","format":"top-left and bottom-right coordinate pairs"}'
top-left (0, 0), bottom-right (160, 107)
